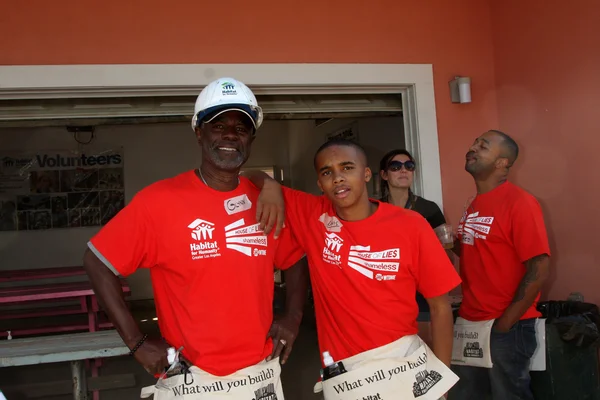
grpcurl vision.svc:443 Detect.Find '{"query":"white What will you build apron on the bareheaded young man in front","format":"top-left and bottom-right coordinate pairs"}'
top-left (315, 335), bottom-right (458, 400)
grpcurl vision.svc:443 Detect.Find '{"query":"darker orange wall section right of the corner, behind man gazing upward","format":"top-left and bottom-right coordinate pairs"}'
top-left (492, 0), bottom-right (600, 304)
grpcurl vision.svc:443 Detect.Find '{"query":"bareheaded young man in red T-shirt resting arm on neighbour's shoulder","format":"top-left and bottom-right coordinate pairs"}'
top-left (249, 140), bottom-right (460, 398)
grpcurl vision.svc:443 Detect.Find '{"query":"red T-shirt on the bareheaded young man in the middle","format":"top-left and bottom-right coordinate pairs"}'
top-left (284, 188), bottom-right (460, 360)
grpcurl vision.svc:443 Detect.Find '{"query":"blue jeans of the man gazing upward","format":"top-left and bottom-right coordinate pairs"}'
top-left (448, 319), bottom-right (537, 400)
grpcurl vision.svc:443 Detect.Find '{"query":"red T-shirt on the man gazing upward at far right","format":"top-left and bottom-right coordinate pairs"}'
top-left (458, 182), bottom-right (550, 321)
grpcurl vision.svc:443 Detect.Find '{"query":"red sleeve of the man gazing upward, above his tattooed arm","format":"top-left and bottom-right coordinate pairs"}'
top-left (511, 195), bottom-right (550, 263)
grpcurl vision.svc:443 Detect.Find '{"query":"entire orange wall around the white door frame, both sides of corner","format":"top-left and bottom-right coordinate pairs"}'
top-left (0, 0), bottom-right (600, 303)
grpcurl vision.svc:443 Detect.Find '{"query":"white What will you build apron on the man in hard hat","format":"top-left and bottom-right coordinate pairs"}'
top-left (141, 358), bottom-right (284, 400)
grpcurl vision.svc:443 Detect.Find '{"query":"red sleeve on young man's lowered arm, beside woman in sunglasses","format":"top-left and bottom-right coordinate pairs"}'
top-left (415, 218), bottom-right (461, 298)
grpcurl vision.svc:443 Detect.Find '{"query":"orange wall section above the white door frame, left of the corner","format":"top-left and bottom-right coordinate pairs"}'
top-left (0, 0), bottom-right (498, 230)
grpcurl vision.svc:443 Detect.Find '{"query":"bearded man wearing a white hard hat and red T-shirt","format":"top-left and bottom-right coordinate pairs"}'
top-left (84, 78), bottom-right (308, 388)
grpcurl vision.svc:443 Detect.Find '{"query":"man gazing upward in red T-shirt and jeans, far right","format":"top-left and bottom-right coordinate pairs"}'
top-left (449, 131), bottom-right (550, 400)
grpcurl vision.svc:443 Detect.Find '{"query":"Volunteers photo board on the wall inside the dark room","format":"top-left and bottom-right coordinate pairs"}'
top-left (0, 151), bottom-right (125, 231)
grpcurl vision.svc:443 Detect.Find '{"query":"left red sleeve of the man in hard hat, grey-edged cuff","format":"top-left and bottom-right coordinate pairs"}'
top-left (88, 194), bottom-right (157, 276)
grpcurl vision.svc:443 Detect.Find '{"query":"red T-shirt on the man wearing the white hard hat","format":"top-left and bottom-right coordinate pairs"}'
top-left (89, 171), bottom-right (303, 376)
